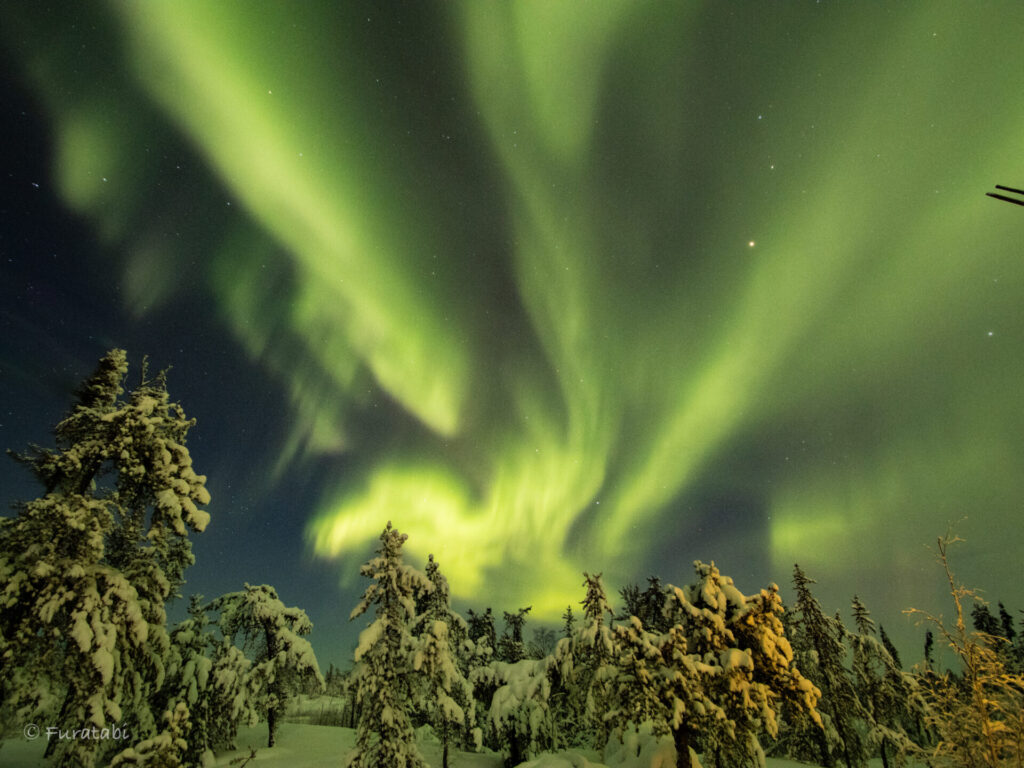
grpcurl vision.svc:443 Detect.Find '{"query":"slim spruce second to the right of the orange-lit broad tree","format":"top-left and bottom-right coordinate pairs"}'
top-left (847, 595), bottom-right (924, 768)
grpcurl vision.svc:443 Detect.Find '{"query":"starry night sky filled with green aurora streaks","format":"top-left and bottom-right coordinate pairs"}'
top-left (0, 0), bottom-right (1024, 668)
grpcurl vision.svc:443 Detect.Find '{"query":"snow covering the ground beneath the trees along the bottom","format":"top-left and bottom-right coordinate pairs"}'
top-left (0, 723), bottom-right (929, 768)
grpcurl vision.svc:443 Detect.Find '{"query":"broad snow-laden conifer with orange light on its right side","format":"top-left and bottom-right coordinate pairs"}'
top-left (607, 561), bottom-right (819, 768)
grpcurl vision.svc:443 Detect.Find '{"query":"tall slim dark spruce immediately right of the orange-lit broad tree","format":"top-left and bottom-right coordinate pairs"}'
top-left (790, 565), bottom-right (866, 768)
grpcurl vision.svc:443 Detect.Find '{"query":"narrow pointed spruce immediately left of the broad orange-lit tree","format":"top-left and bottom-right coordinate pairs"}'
top-left (554, 572), bottom-right (615, 750)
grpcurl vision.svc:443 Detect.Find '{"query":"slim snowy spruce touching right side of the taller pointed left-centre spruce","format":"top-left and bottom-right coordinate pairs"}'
top-left (413, 555), bottom-right (480, 768)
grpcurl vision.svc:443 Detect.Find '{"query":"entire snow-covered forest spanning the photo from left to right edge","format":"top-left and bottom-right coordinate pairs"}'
top-left (0, 349), bottom-right (1024, 768)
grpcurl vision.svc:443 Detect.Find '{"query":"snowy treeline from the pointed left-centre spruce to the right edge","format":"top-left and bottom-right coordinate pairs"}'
top-left (339, 523), bottom-right (1024, 768)
